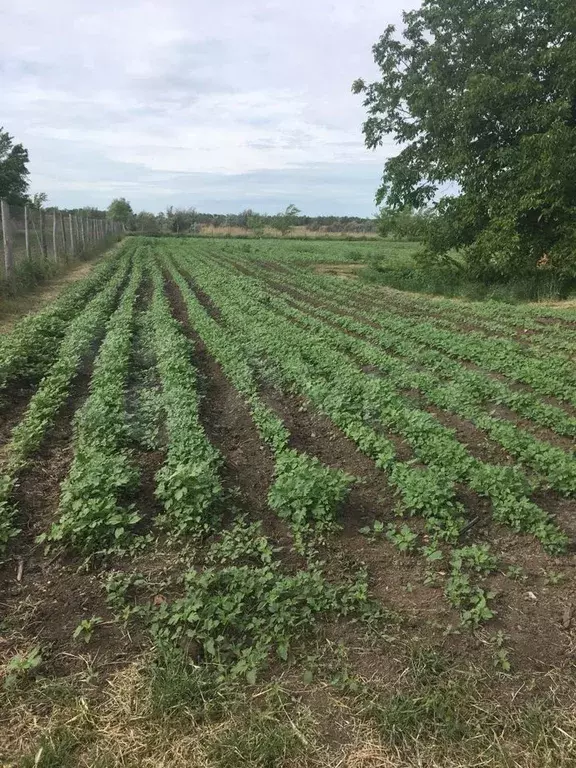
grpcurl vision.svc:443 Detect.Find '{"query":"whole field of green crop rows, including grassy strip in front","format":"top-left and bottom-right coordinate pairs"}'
top-left (0, 237), bottom-right (576, 768)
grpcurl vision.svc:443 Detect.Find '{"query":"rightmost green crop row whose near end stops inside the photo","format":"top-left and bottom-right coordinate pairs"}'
top-left (176, 252), bottom-right (566, 550)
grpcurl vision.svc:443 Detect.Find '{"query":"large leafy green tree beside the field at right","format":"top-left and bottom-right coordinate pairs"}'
top-left (353, 0), bottom-right (576, 277)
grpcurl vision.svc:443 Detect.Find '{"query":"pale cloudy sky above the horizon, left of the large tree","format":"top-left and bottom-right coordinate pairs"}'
top-left (0, 0), bottom-right (418, 215)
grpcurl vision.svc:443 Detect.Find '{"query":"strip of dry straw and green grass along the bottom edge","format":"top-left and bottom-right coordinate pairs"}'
top-left (0, 642), bottom-right (576, 768)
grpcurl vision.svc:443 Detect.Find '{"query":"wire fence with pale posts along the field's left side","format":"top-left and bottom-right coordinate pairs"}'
top-left (0, 199), bottom-right (123, 281)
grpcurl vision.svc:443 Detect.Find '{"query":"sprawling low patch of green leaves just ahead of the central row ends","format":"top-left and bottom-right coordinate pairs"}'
top-left (137, 564), bottom-right (368, 683)
